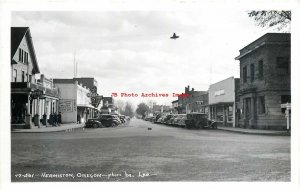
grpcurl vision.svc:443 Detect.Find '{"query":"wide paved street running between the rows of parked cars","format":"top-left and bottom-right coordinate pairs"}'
top-left (11, 119), bottom-right (291, 181)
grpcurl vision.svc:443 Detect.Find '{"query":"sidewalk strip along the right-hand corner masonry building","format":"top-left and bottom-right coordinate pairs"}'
top-left (217, 126), bottom-right (291, 136)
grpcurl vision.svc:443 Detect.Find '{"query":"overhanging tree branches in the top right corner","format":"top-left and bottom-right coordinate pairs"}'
top-left (248, 10), bottom-right (292, 31)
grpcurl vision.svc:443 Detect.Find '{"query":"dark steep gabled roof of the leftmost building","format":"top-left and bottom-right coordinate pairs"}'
top-left (10, 27), bottom-right (40, 73)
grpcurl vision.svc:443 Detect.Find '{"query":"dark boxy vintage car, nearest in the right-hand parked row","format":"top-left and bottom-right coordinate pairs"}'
top-left (185, 113), bottom-right (217, 129)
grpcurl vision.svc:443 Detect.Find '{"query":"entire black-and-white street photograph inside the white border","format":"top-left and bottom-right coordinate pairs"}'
top-left (7, 7), bottom-right (294, 183)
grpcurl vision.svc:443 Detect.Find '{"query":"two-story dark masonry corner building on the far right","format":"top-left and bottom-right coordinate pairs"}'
top-left (235, 33), bottom-right (291, 129)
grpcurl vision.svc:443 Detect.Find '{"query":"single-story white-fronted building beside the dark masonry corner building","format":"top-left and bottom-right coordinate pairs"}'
top-left (208, 77), bottom-right (239, 127)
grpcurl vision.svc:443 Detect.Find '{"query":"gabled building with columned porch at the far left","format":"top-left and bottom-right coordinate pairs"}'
top-left (11, 27), bottom-right (58, 128)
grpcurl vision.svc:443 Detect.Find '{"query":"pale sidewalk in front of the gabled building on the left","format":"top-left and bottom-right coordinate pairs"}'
top-left (11, 123), bottom-right (84, 133)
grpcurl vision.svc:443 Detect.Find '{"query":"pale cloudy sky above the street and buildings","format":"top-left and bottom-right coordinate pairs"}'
top-left (11, 8), bottom-right (276, 105)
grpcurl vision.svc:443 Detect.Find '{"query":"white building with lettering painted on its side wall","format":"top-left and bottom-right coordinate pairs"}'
top-left (53, 78), bottom-right (99, 123)
